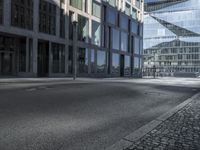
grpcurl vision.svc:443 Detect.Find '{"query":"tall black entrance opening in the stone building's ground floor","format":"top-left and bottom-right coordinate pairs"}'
top-left (38, 42), bottom-right (49, 77)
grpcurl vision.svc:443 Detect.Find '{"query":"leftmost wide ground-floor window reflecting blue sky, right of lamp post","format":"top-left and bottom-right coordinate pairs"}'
top-left (97, 50), bottom-right (106, 73)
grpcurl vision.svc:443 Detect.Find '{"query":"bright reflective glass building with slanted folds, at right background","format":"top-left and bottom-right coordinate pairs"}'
top-left (143, 0), bottom-right (200, 76)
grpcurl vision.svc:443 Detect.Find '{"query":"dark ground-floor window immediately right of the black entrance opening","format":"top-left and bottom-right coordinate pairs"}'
top-left (52, 43), bottom-right (65, 73)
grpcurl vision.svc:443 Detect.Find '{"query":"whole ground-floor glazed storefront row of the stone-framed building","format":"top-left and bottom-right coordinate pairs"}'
top-left (0, 33), bottom-right (141, 77)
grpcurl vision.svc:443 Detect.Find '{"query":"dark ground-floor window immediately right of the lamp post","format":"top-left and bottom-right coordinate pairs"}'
top-left (78, 48), bottom-right (88, 73)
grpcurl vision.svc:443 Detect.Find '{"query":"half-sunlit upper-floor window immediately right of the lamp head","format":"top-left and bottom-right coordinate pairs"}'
top-left (78, 15), bottom-right (89, 42)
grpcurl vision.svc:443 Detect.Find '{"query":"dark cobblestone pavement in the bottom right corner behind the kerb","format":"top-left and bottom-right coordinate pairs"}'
top-left (126, 98), bottom-right (200, 150)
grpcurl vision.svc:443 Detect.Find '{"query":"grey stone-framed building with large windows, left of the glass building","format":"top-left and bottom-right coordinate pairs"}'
top-left (0, 0), bottom-right (143, 77)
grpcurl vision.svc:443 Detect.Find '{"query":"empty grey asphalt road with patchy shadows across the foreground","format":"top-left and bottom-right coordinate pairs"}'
top-left (0, 82), bottom-right (199, 150)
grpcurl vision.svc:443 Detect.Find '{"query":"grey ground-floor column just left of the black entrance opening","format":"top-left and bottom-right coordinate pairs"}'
top-left (33, 38), bottom-right (38, 76)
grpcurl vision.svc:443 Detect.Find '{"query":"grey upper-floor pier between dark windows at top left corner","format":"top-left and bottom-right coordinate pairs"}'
top-left (3, 0), bottom-right (11, 28)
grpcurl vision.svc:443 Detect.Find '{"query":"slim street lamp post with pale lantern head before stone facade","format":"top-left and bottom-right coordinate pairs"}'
top-left (71, 13), bottom-right (78, 80)
